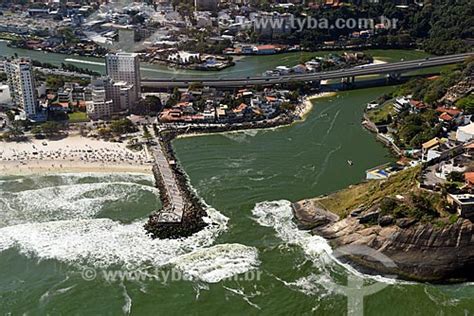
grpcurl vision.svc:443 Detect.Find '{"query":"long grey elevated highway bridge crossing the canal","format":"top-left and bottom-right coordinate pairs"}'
top-left (142, 53), bottom-right (474, 88)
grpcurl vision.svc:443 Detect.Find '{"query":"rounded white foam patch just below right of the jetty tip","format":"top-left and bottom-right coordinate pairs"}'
top-left (171, 244), bottom-right (259, 283)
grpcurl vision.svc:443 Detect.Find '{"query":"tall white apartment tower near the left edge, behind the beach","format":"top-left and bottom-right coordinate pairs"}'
top-left (5, 58), bottom-right (38, 118)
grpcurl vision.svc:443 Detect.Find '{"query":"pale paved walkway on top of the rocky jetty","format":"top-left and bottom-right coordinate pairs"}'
top-left (150, 144), bottom-right (184, 223)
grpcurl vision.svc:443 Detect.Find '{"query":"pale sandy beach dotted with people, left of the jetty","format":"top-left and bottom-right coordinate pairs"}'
top-left (0, 136), bottom-right (152, 175)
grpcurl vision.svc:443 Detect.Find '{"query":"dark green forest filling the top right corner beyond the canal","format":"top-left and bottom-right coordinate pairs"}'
top-left (251, 0), bottom-right (474, 55)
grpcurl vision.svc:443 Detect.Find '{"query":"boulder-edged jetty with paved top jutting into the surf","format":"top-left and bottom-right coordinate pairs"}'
top-left (145, 133), bottom-right (207, 239)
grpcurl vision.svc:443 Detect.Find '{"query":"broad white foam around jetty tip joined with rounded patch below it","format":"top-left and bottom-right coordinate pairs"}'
top-left (0, 210), bottom-right (259, 283)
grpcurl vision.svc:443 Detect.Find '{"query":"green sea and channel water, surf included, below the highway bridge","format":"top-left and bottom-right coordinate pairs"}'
top-left (0, 88), bottom-right (474, 315)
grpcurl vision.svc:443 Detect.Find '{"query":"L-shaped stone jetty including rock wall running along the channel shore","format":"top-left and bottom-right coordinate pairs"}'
top-left (145, 115), bottom-right (299, 239)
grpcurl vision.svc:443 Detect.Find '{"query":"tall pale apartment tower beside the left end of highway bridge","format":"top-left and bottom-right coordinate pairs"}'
top-left (105, 53), bottom-right (141, 110)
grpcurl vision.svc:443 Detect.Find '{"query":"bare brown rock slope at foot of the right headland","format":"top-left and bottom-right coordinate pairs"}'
top-left (293, 201), bottom-right (474, 283)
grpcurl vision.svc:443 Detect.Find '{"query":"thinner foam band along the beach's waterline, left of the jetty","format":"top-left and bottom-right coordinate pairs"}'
top-left (0, 179), bottom-right (158, 227)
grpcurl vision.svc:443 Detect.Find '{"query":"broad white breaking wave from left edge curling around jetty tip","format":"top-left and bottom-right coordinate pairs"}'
top-left (0, 202), bottom-right (228, 269)
